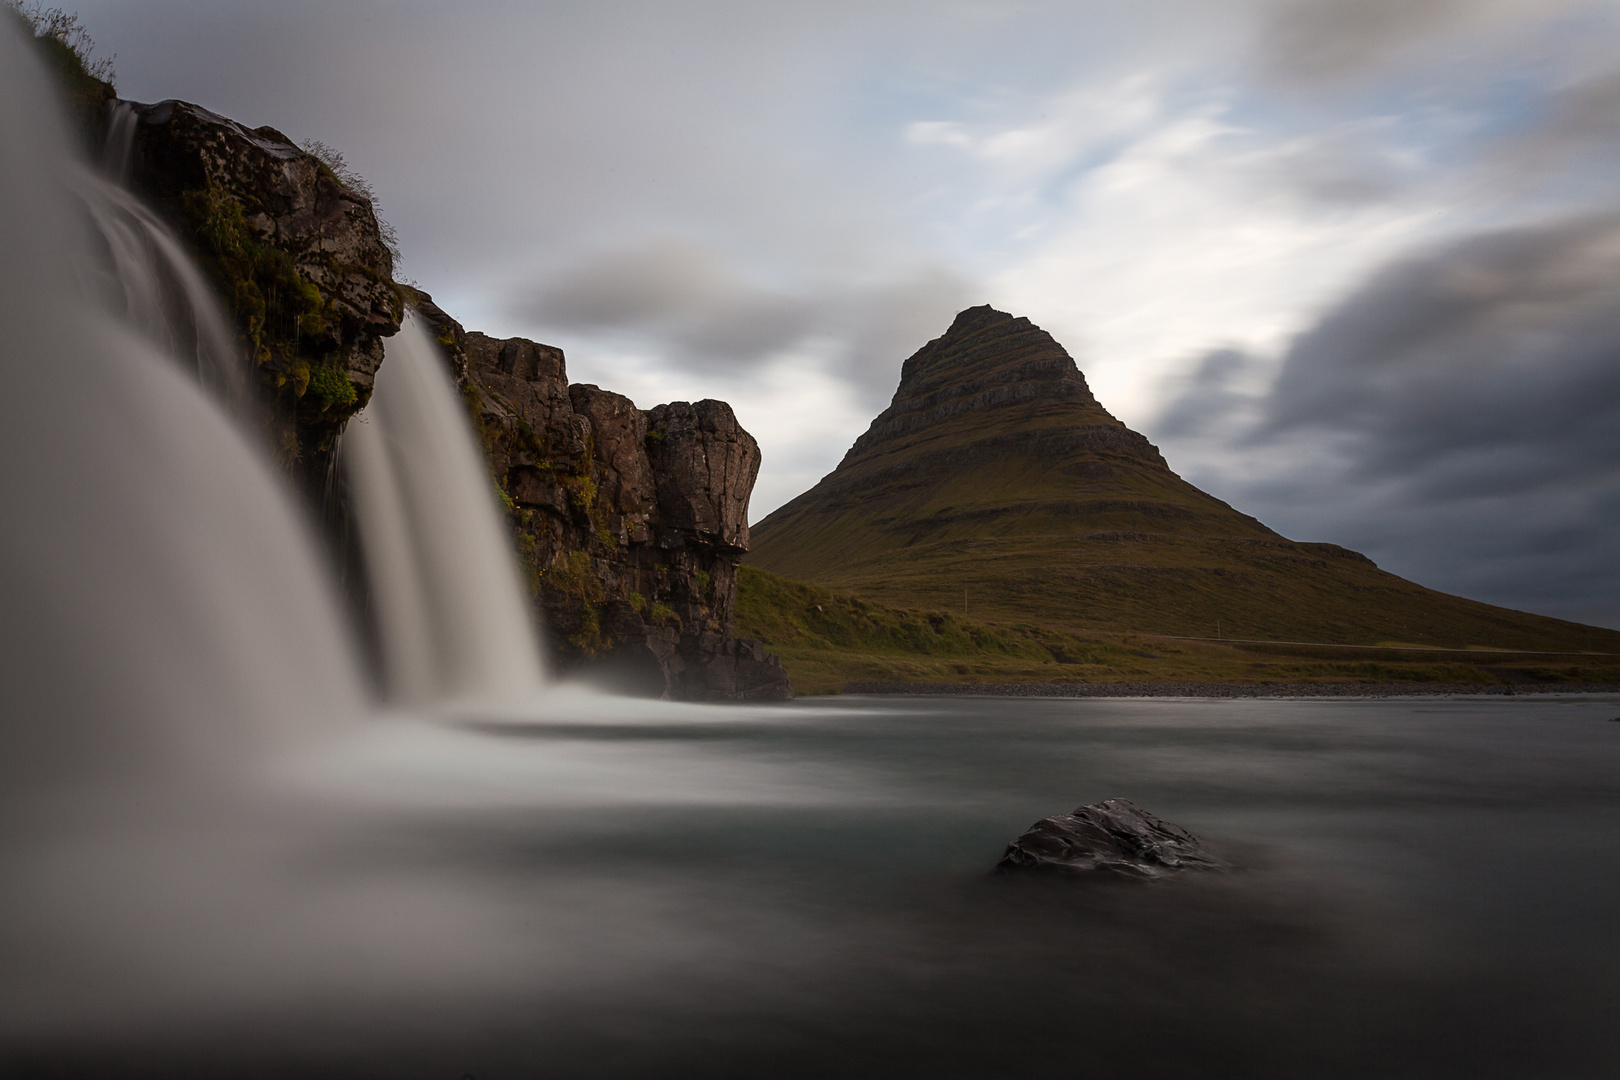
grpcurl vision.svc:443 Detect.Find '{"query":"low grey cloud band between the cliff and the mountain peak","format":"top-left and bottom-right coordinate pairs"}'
top-left (518, 241), bottom-right (975, 397)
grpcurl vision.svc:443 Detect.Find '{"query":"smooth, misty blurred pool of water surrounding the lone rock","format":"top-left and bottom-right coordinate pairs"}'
top-left (0, 693), bottom-right (1620, 1080)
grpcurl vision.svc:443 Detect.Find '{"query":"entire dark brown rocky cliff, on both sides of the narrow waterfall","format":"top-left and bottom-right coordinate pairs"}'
top-left (130, 100), bottom-right (792, 699)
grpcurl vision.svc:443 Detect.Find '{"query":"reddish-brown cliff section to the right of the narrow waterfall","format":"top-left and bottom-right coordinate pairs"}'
top-left (415, 293), bottom-right (792, 701)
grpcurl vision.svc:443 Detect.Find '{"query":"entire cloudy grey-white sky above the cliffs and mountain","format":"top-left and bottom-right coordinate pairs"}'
top-left (70, 0), bottom-right (1620, 628)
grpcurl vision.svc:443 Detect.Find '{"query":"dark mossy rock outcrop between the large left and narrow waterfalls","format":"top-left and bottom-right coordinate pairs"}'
top-left (131, 100), bottom-right (405, 478)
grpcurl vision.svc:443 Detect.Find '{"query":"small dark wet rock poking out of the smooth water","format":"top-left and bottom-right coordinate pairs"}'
top-left (996, 798), bottom-right (1228, 879)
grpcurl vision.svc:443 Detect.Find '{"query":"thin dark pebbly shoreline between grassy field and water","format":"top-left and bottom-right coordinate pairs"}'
top-left (838, 682), bottom-right (1620, 698)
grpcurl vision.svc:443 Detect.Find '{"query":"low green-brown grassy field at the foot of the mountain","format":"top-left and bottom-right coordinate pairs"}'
top-left (735, 567), bottom-right (1620, 695)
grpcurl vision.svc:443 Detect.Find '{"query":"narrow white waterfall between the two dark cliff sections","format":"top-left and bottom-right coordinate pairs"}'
top-left (340, 314), bottom-right (543, 704)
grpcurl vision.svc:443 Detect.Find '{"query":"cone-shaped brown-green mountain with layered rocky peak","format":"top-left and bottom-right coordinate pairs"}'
top-left (747, 306), bottom-right (1620, 653)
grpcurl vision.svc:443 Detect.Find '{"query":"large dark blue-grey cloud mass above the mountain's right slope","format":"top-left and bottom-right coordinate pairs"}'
top-left (1152, 212), bottom-right (1620, 627)
